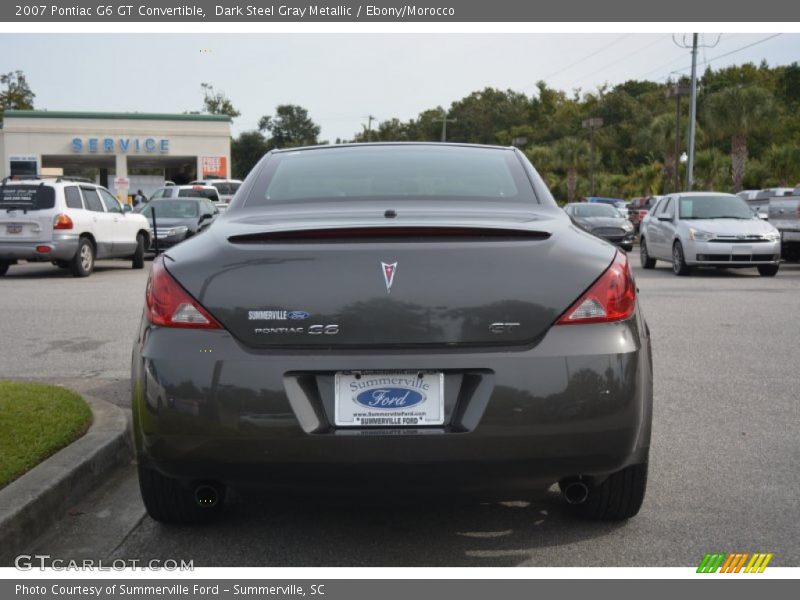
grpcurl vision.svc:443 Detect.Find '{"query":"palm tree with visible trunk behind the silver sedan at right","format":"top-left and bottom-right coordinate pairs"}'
top-left (705, 86), bottom-right (772, 192)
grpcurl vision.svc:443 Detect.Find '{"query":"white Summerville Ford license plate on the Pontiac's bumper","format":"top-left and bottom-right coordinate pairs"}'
top-left (334, 371), bottom-right (444, 427)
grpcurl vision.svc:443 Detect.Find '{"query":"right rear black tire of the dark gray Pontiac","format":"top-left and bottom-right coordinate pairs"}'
top-left (569, 463), bottom-right (647, 521)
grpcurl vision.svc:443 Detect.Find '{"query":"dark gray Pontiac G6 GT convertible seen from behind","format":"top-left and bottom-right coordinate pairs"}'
top-left (132, 144), bottom-right (652, 523)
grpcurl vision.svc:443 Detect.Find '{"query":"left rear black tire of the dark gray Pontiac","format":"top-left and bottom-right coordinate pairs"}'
top-left (139, 465), bottom-right (225, 525)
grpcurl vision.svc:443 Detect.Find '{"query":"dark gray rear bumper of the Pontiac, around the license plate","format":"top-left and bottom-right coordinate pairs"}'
top-left (133, 308), bottom-right (652, 491)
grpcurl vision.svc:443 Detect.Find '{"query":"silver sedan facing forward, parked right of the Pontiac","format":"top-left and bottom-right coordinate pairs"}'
top-left (639, 192), bottom-right (781, 277)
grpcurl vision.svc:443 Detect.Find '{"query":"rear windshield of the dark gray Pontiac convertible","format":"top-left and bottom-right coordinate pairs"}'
top-left (247, 145), bottom-right (536, 206)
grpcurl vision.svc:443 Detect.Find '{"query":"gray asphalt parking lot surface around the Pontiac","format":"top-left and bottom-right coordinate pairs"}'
top-left (0, 255), bottom-right (800, 566)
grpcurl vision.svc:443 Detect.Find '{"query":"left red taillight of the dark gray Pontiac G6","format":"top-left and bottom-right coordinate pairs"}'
top-left (145, 256), bottom-right (222, 329)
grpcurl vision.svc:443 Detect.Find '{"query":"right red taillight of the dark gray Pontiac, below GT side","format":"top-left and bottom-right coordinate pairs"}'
top-left (556, 251), bottom-right (636, 325)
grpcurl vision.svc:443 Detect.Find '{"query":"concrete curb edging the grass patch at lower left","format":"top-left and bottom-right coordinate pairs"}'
top-left (0, 395), bottom-right (132, 565)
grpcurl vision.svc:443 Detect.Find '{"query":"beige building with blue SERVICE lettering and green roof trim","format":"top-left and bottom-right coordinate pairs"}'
top-left (0, 110), bottom-right (231, 201)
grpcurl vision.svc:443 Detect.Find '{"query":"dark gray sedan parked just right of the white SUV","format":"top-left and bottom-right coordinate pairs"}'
top-left (139, 198), bottom-right (219, 252)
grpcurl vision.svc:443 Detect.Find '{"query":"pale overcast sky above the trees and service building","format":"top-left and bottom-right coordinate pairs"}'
top-left (0, 33), bottom-right (800, 142)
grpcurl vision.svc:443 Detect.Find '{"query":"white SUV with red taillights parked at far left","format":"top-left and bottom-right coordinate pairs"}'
top-left (0, 177), bottom-right (150, 277)
